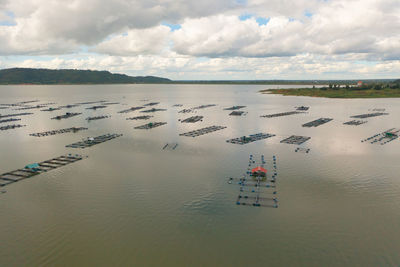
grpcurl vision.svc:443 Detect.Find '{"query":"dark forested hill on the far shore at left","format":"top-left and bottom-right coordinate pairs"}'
top-left (0, 68), bottom-right (171, 84)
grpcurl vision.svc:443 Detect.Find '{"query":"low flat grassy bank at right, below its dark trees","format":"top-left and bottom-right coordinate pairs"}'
top-left (260, 88), bottom-right (400, 98)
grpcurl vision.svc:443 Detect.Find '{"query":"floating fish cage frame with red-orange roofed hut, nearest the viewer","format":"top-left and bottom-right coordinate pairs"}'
top-left (228, 155), bottom-right (278, 208)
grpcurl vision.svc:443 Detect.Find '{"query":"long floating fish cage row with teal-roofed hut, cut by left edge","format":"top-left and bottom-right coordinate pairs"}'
top-left (0, 154), bottom-right (83, 186)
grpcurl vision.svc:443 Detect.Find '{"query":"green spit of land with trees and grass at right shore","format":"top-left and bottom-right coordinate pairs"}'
top-left (260, 80), bottom-right (400, 98)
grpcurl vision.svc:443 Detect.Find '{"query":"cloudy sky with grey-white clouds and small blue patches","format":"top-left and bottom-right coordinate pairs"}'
top-left (0, 0), bottom-right (400, 80)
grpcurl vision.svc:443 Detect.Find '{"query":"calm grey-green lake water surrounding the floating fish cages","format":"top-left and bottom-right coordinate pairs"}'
top-left (0, 85), bottom-right (400, 266)
